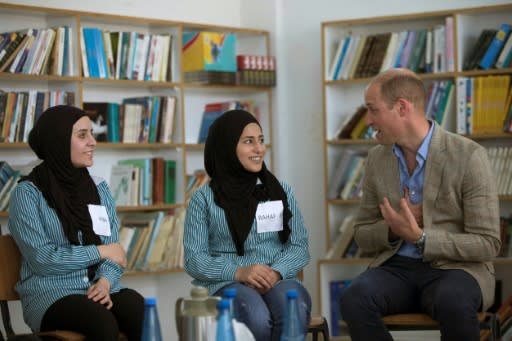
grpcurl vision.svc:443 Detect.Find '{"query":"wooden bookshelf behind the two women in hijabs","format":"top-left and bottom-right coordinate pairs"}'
top-left (0, 3), bottom-right (273, 278)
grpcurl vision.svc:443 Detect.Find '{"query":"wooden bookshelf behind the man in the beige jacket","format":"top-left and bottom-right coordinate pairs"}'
top-left (317, 4), bottom-right (512, 340)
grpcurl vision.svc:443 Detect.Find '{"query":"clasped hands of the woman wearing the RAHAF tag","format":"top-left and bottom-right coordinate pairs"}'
top-left (235, 264), bottom-right (281, 294)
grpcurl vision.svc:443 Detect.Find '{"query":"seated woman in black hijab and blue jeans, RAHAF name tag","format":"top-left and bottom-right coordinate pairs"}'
top-left (184, 110), bottom-right (311, 341)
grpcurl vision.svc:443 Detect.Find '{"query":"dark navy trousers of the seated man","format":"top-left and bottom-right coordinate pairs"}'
top-left (340, 255), bottom-right (482, 341)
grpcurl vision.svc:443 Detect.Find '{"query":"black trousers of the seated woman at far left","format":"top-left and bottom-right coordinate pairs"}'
top-left (41, 289), bottom-right (144, 341)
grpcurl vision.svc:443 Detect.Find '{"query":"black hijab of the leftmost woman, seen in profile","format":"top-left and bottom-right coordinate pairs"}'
top-left (21, 105), bottom-right (101, 245)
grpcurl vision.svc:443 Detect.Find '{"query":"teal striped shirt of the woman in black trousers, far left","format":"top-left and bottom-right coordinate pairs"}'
top-left (8, 177), bottom-right (123, 331)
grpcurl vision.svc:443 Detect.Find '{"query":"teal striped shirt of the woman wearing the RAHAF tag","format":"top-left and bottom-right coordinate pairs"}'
top-left (183, 182), bottom-right (311, 294)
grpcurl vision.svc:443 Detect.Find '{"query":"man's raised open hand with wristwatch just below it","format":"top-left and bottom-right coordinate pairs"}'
top-left (379, 196), bottom-right (422, 242)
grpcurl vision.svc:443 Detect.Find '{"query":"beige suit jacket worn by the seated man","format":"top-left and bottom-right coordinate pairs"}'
top-left (355, 124), bottom-right (500, 308)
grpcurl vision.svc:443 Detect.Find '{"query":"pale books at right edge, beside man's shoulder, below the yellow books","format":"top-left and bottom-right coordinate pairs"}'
top-left (487, 146), bottom-right (512, 195)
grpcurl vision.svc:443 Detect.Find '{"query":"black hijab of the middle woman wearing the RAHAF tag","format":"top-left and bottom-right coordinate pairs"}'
top-left (204, 110), bottom-right (292, 256)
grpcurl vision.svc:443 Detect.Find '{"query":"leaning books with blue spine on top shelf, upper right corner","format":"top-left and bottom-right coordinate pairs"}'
top-left (462, 23), bottom-right (512, 70)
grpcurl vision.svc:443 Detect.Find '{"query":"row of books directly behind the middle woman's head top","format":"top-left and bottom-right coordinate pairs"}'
top-left (197, 99), bottom-right (259, 143)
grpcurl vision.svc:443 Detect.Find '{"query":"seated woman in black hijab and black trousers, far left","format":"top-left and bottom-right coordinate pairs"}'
top-left (9, 105), bottom-right (144, 341)
